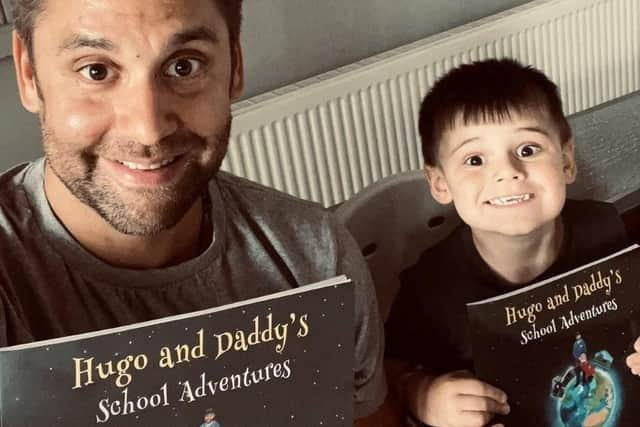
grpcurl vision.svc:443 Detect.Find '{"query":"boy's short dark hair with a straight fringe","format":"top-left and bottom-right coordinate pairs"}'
top-left (418, 59), bottom-right (571, 166)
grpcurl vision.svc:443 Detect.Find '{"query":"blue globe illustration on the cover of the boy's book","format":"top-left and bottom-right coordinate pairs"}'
top-left (560, 369), bottom-right (616, 427)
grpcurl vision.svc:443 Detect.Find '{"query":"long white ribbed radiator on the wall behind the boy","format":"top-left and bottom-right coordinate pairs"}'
top-left (223, 0), bottom-right (640, 206)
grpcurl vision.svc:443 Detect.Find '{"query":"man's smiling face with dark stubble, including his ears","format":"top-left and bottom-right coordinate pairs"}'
top-left (18, 0), bottom-right (242, 235)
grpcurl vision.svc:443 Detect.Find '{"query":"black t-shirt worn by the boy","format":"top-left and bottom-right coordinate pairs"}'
top-left (385, 200), bottom-right (630, 375)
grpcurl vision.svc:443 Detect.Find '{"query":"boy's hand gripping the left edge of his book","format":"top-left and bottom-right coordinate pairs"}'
top-left (419, 371), bottom-right (509, 427)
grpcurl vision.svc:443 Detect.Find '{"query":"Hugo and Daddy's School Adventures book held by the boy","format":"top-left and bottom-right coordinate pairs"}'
top-left (467, 245), bottom-right (640, 427)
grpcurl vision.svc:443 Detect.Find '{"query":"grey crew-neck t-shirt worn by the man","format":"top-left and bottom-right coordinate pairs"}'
top-left (0, 159), bottom-right (385, 417)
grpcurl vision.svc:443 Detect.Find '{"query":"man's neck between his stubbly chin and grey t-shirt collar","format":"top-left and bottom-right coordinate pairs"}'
top-left (44, 165), bottom-right (203, 269)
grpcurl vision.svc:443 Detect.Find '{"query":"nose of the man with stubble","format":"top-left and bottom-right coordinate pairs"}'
top-left (117, 78), bottom-right (179, 145)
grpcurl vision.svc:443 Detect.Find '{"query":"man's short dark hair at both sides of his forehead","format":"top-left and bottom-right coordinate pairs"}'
top-left (13, 0), bottom-right (242, 60)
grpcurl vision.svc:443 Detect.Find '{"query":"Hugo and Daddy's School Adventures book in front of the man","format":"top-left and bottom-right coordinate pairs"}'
top-left (0, 276), bottom-right (354, 427)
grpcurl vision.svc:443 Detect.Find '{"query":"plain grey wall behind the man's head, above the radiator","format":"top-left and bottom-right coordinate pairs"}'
top-left (0, 0), bottom-right (529, 170)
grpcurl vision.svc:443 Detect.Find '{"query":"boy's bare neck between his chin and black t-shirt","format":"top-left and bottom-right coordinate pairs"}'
top-left (472, 217), bottom-right (564, 286)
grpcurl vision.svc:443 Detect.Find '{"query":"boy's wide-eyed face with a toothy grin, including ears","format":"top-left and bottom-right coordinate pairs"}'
top-left (426, 114), bottom-right (576, 236)
